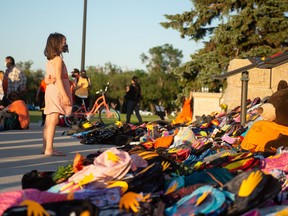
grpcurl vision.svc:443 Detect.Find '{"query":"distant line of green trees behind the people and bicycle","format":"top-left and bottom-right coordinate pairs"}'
top-left (17, 44), bottom-right (187, 111)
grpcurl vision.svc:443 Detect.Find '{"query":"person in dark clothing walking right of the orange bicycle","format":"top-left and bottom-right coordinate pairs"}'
top-left (125, 76), bottom-right (142, 124)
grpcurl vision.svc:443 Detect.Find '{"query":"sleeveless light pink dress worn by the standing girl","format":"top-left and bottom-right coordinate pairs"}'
top-left (44, 61), bottom-right (73, 115)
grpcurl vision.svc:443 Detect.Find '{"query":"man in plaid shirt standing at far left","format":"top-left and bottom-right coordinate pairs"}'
top-left (4, 56), bottom-right (27, 101)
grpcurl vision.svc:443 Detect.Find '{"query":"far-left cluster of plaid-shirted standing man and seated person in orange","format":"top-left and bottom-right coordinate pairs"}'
top-left (0, 56), bottom-right (30, 130)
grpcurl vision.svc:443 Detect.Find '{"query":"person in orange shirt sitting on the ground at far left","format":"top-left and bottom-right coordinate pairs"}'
top-left (0, 92), bottom-right (30, 130)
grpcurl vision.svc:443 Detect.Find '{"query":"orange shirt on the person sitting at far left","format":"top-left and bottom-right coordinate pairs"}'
top-left (7, 100), bottom-right (30, 129)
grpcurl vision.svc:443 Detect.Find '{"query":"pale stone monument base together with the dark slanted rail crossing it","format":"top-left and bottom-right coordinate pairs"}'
top-left (193, 52), bottom-right (288, 120)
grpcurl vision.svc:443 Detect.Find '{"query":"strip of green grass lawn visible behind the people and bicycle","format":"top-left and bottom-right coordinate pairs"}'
top-left (29, 110), bottom-right (173, 123)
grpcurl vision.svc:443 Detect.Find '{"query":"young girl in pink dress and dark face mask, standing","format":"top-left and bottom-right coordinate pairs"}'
top-left (42, 33), bottom-right (72, 156)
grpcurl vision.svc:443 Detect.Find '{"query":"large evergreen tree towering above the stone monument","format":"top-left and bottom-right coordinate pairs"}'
top-left (161, 0), bottom-right (288, 91)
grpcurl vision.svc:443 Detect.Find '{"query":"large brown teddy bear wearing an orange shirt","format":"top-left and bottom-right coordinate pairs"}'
top-left (241, 80), bottom-right (288, 154)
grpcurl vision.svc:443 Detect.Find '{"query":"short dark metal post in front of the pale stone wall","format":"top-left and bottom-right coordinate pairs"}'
top-left (240, 71), bottom-right (249, 125)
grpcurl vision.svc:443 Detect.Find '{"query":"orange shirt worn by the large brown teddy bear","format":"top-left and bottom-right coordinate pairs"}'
top-left (241, 120), bottom-right (288, 152)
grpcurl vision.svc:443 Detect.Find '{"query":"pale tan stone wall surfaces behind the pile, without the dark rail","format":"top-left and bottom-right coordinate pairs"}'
top-left (193, 59), bottom-right (288, 120)
